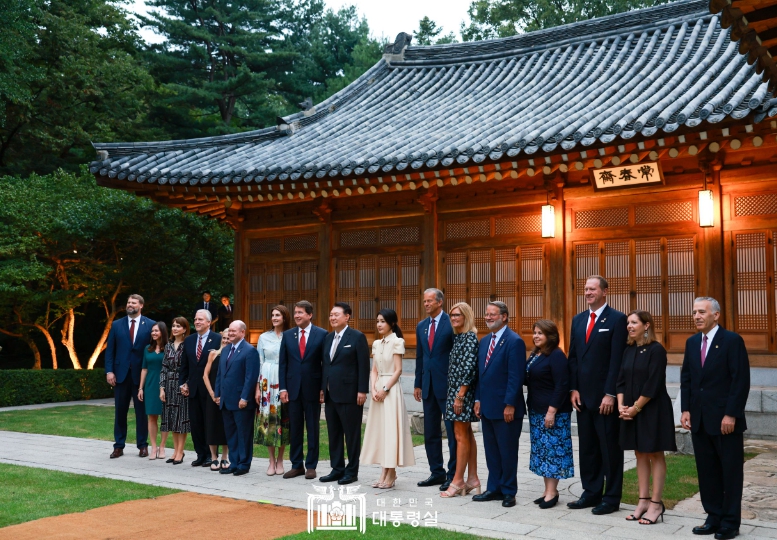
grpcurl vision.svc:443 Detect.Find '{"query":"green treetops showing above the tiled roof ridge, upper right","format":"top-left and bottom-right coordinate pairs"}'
top-left (461, 0), bottom-right (668, 41)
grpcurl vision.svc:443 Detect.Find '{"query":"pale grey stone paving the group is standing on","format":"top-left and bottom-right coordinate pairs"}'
top-left (0, 424), bottom-right (777, 540)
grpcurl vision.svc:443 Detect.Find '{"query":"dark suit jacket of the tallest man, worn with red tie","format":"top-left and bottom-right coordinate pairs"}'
top-left (568, 304), bottom-right (628, 409)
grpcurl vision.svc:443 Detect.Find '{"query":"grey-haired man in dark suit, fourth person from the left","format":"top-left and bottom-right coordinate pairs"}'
top-left (178, 309), bottom-right (221, 467)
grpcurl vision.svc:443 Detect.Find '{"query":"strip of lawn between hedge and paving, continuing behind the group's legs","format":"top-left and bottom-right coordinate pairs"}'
top-left (0, 405), bottom-right (424, 460)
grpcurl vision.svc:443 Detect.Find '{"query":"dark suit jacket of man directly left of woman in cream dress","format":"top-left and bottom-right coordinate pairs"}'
top-left (321, 326), bottom-right (370, 403)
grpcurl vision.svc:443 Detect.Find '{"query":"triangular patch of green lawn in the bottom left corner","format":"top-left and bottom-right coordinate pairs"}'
top-left (0, 463), bottom-right (178, 536)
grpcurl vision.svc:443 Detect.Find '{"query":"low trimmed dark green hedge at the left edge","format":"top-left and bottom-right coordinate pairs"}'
top-left (0, 369), bottom-right (113, 407)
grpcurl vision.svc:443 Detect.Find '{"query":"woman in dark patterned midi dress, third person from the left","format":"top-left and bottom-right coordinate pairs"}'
top-left (159, 317), bottom-right (191, 465)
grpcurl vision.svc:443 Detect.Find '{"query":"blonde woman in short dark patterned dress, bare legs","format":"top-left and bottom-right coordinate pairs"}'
top-left (440, 302), bottom-right (480, 498)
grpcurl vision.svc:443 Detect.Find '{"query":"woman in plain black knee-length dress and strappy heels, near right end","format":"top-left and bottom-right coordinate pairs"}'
top-left (616, 311), bottom-right (677, 525)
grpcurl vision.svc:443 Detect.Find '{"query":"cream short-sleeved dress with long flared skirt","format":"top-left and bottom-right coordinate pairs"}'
top-left (360, 332), bottom-right (415, 469)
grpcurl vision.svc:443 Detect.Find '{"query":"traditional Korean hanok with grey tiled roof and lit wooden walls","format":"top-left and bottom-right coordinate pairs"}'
top-left (91, 0), bottom-right (777, 376)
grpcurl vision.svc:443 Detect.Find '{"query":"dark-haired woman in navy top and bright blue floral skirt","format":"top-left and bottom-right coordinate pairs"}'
top-left (526, 319), bottom-right (575, 509)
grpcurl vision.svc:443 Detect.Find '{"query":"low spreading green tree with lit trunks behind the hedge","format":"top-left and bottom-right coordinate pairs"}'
top-left (0, 171), bottom-right (233, 369)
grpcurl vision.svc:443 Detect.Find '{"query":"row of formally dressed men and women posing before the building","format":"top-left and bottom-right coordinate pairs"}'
top-left (101, 275), bottom-right (750, 539)
